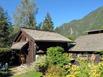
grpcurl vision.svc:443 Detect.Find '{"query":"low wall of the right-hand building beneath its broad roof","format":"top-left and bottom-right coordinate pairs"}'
top-left (69, 51), bottom-right (101, 63)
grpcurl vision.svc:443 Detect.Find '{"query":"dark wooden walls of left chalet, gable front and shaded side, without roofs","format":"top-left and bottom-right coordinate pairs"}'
top-left (13, 31), bottom-right (68, 64)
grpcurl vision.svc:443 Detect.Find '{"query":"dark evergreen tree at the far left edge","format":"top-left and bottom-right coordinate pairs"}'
top-left (0, 7), bottom-right (10, 47)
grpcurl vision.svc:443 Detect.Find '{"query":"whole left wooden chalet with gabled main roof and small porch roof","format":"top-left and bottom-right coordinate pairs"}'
top-left (11, 28), bottom-right (71, 64)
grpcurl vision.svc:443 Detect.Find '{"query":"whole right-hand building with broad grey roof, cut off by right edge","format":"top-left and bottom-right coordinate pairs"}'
top-left (69, 30), bottom-right (103, 62)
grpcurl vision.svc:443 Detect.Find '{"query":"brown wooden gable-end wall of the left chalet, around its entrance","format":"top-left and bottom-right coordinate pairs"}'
top-left (13, 31), bottom-right (36, 64)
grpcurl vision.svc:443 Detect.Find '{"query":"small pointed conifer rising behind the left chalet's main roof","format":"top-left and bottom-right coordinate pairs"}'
top-left (42, 13), bottom-right (54, 31)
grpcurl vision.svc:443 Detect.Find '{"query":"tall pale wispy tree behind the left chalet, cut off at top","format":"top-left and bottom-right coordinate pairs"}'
top-left (14, 0), bottom-right (37, 28)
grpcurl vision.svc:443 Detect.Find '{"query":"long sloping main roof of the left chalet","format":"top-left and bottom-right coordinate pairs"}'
top-left (21, 28), bottom-right (71, 42)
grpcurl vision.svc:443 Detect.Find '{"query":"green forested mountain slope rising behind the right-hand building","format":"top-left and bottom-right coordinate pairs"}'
top-left (55, 6), bottom-right (103, 39)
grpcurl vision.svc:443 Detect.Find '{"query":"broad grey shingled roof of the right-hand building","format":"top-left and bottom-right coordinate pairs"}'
top-left (71, 33), bottom-right (103, 51)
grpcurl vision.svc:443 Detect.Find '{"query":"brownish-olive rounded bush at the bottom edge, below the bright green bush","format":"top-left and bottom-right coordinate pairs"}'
top-left (44, 65), bottom-right (65, 77)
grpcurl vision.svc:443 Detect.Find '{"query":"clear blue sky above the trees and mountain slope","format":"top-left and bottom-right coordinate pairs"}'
top-left (0, 0), bottom-right (103, 27)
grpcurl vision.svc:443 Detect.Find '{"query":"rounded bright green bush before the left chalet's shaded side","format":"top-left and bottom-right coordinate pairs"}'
top-left (47, 47), bottom-right (70, 66)
